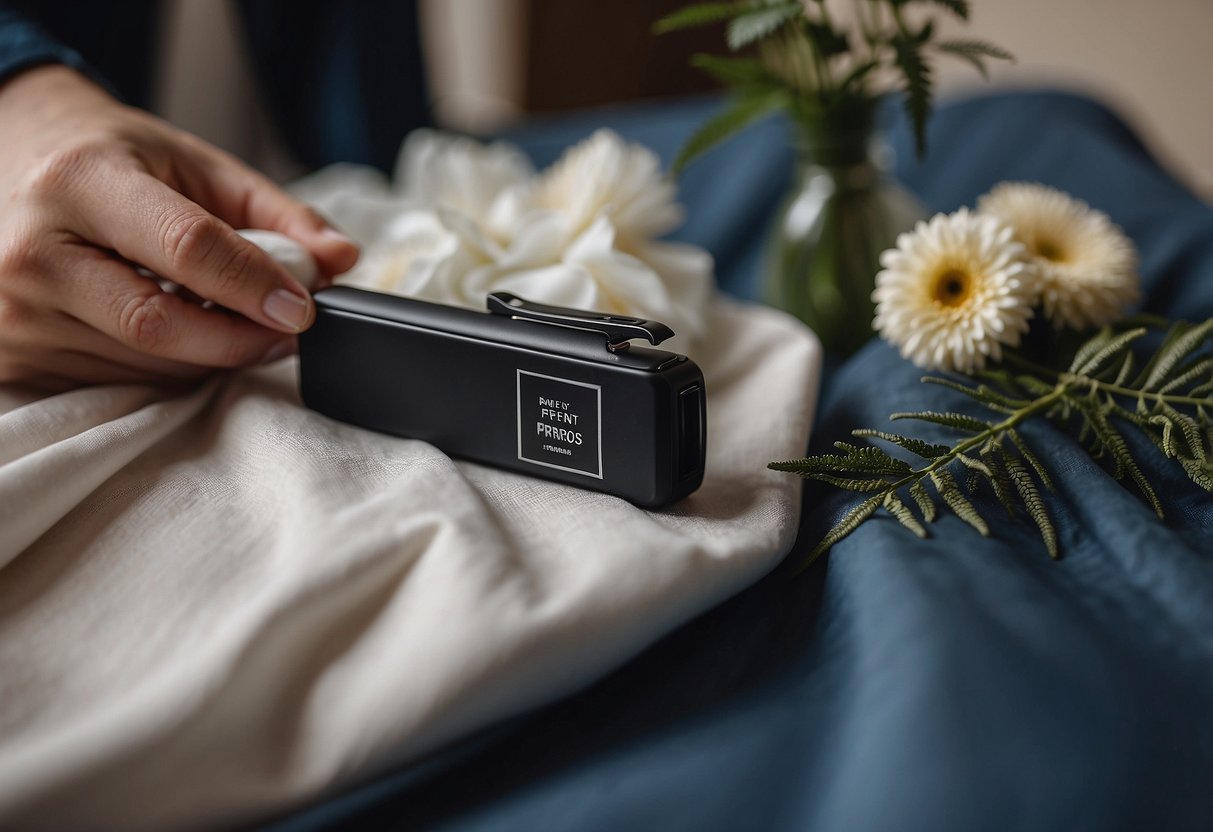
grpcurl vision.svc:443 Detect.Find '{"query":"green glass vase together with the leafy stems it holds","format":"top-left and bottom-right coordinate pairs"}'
top-left (654, 0), bottom-right (1012, 358)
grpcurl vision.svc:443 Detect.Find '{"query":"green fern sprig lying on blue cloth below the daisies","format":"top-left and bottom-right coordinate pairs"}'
top-left (770, 319), bottom-right (1213, 565)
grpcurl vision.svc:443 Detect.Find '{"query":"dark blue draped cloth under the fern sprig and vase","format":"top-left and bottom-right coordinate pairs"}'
top-left (273, 93), bottom-right (1213, 832)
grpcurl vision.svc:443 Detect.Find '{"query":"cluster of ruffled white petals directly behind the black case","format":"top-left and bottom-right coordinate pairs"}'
top-left (295, 130), bottom-right (714, 357)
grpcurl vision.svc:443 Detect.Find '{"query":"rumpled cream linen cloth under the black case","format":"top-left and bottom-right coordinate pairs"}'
top-left (0, 301), bottom-right (820, 830)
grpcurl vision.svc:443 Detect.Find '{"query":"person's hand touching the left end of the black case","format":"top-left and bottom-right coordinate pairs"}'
top-left (0, 65), bottom-right (358, 389)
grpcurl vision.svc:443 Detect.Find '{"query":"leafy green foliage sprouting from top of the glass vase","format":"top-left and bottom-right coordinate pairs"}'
top-left (653, 0), bottom-right (1012, 167)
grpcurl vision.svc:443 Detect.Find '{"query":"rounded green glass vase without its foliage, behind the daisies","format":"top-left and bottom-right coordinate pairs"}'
top-left (767, 102), bottom-right (926, 358)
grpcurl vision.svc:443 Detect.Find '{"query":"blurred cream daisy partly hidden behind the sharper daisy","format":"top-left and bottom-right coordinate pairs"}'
top-left (978, 182), bottom-right (1140, 330)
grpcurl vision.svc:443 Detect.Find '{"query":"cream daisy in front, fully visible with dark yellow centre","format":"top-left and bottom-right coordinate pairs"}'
top-left (872, 209), bottom-right (1036, 372)
